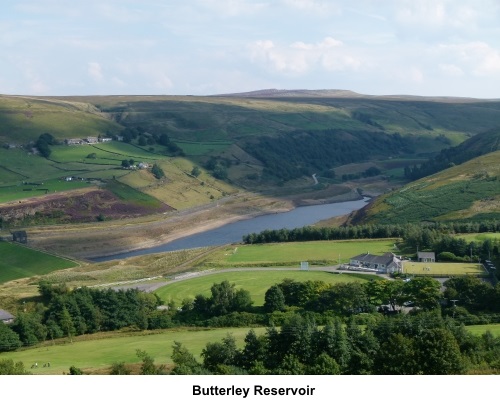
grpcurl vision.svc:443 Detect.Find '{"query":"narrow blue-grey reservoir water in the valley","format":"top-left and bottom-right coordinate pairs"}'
top-left (91, 198), bottom-right (369, 262)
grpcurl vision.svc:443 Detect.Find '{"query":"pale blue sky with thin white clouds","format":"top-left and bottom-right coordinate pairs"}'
top-left (0, 0), bottom-right (500, 98)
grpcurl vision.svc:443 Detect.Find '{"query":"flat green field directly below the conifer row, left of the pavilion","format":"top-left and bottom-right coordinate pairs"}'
top-left (206, 239), bottom-right (395, 267)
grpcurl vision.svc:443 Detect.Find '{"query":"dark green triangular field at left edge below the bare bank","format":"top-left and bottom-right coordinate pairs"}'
top-left (0, 241), bottom-right (78, 283)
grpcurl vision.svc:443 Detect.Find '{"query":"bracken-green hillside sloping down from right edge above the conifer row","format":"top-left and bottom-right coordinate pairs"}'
top-left (354, 150), bottom-right (500, 224)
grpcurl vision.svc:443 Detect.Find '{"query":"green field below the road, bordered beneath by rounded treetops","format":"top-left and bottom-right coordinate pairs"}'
top-left (155, 270), bottom-right (377, 306)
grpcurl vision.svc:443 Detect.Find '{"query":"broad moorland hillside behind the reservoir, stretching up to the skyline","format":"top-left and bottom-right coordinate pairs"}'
top-left (0, 90), bottom-right (500, 230)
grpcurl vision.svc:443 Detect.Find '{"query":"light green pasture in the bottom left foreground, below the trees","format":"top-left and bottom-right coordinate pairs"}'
top-left (0, 328), bottom-right (265, 374)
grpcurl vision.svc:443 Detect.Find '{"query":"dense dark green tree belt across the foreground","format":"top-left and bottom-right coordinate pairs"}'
top-left (0, 277), bottom-right (500, 374)
